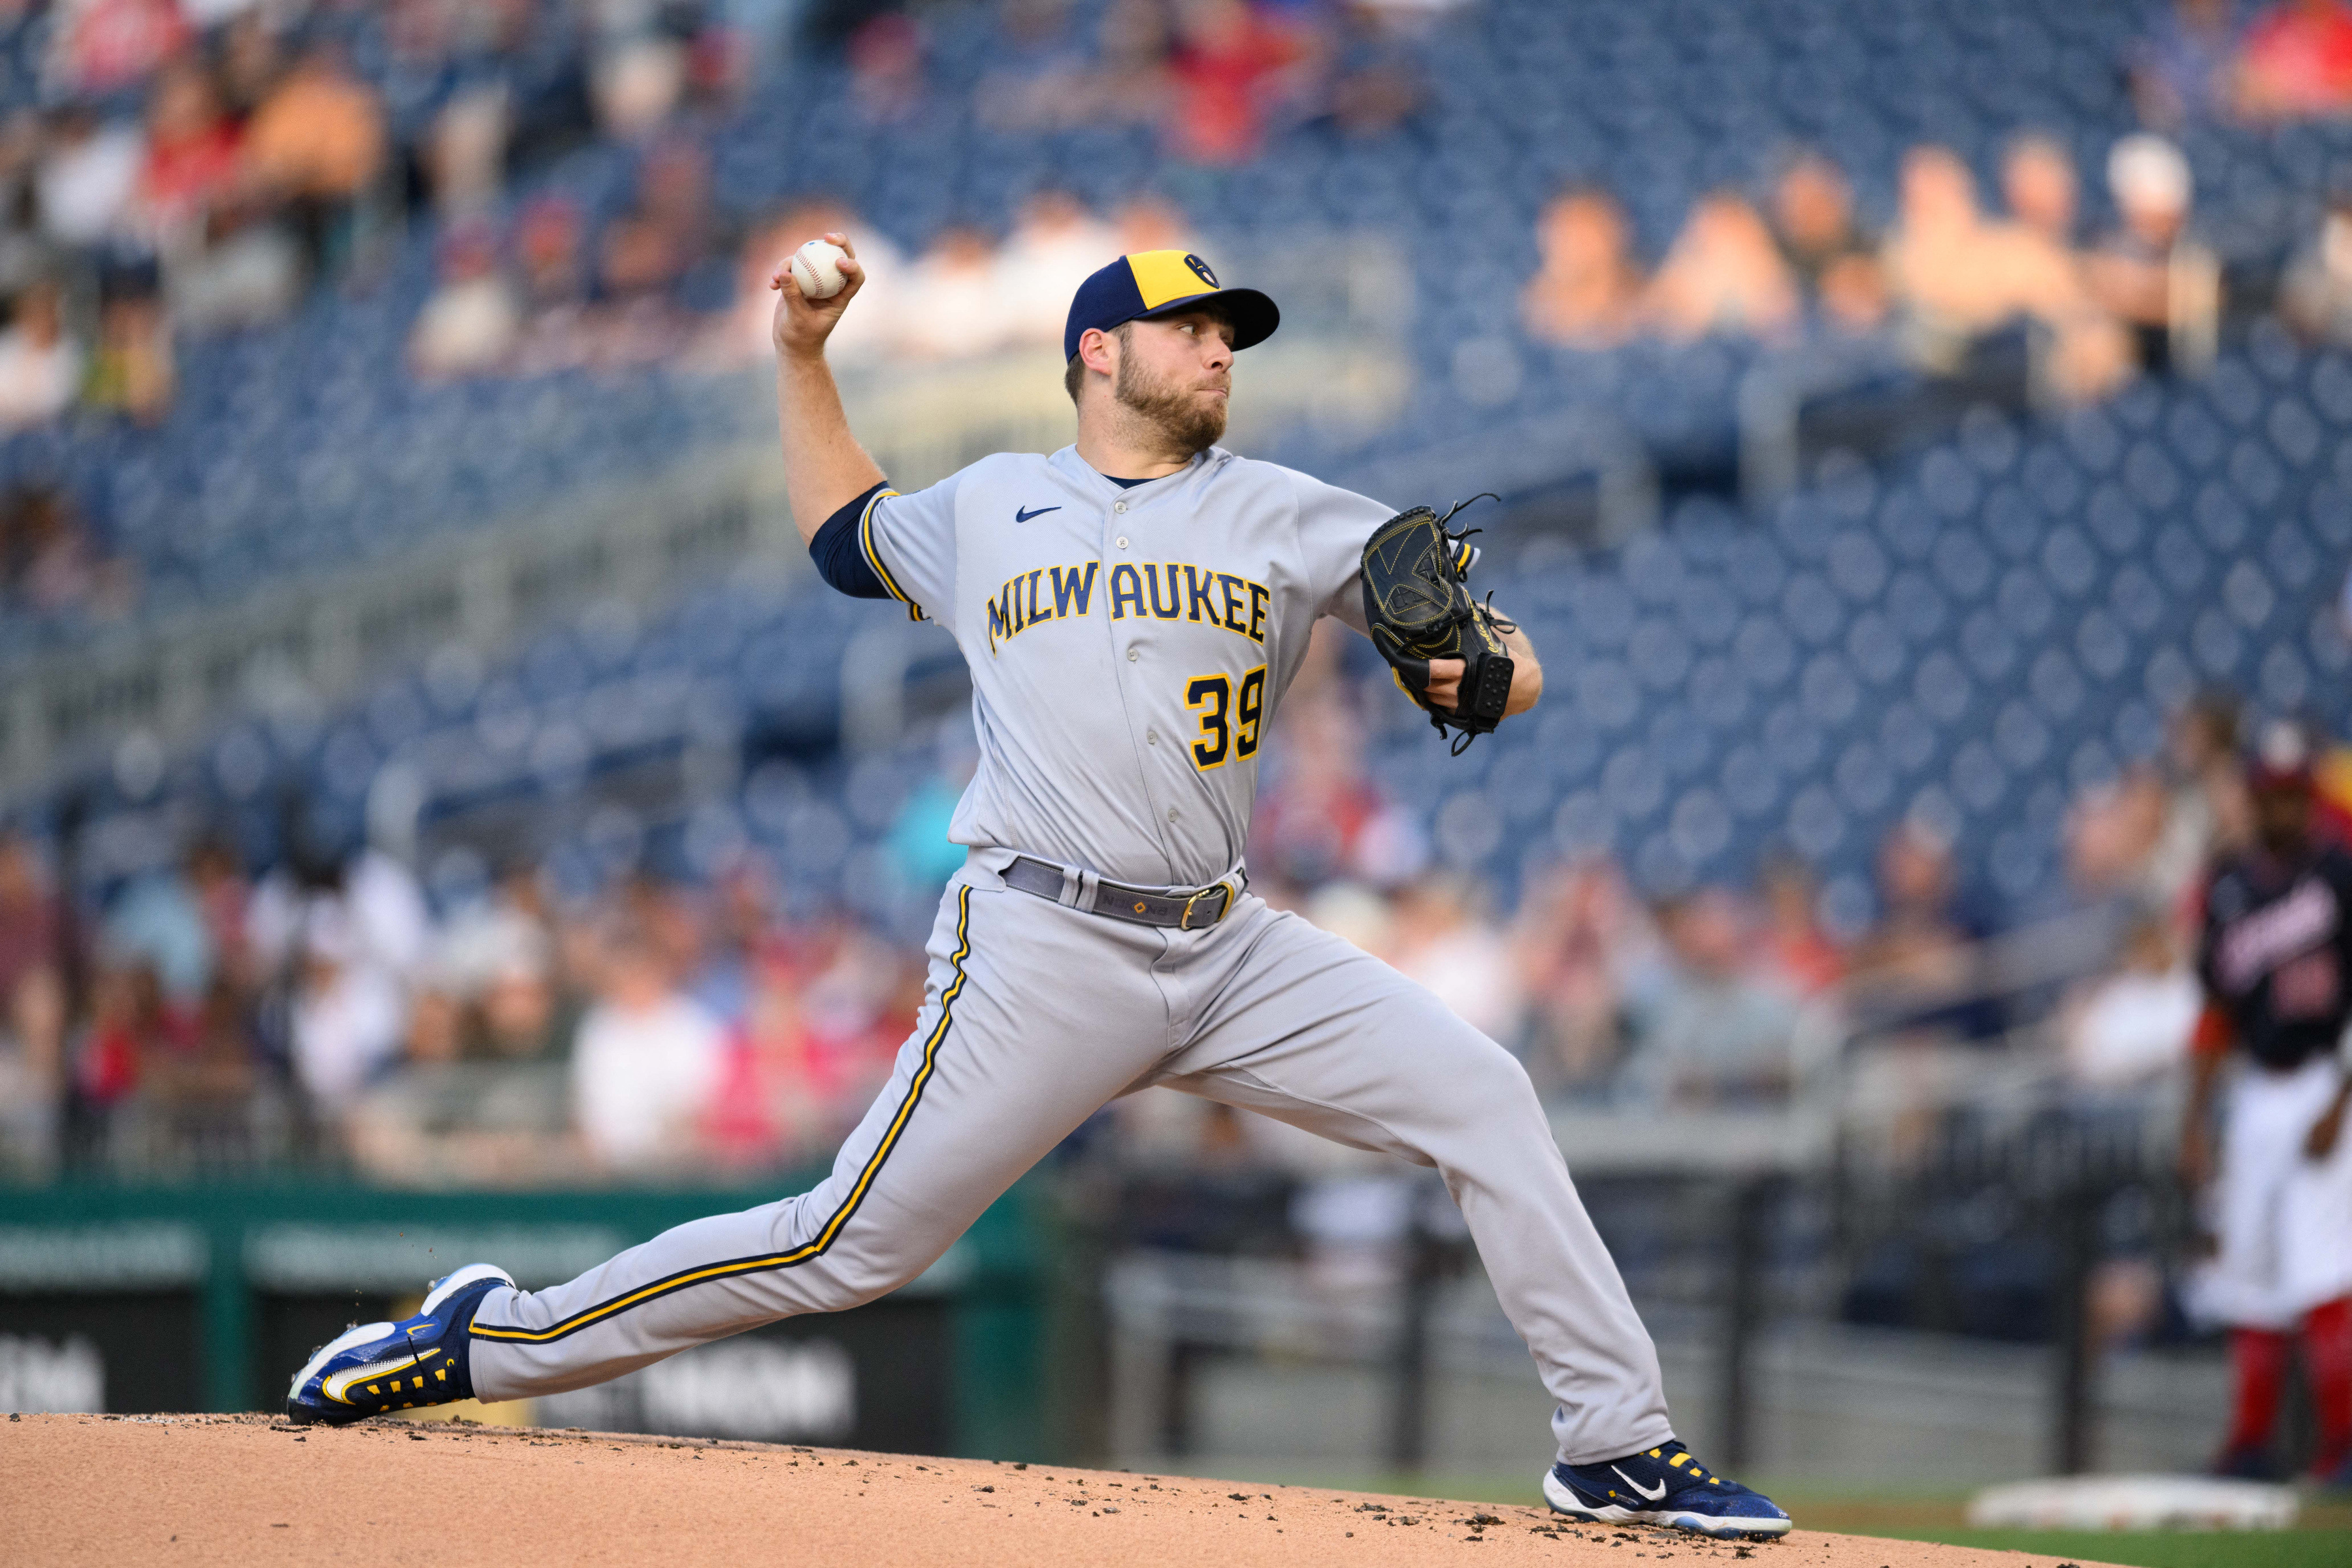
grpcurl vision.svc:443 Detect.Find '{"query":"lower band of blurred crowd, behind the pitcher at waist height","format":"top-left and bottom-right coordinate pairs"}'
top-left (0, 611), bottom-right (2352, 1184)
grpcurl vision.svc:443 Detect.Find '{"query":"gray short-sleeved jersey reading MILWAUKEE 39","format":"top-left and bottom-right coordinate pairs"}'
top-left (858, 447), bottom-right (1392, 887)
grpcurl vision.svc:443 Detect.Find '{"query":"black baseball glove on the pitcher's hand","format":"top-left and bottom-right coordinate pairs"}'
top-left (1364, 496), bottom-right (1517, 757)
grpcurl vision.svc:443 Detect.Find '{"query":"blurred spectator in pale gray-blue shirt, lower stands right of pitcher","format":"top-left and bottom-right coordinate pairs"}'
top-left (1625, 889), bottom-right (1797, 1109)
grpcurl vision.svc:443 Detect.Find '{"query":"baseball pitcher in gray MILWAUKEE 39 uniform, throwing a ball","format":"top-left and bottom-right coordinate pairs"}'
top-left (287, 235), bottom-right (1790, 1537)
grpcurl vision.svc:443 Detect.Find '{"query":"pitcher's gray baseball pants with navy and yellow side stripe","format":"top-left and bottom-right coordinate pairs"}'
top-left (470, 851), bottom-right (1673, 1465)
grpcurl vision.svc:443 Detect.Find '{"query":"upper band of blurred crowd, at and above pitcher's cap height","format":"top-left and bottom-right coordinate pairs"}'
top-left (0, 0), bottom-right (2352, 616)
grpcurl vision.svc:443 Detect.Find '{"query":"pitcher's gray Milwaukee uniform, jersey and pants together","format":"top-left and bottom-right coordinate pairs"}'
top-left (470, 447), bottom-right (1673, 1465)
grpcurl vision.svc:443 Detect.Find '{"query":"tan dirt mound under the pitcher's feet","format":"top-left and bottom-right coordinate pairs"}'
top-left (0, 1415), bottom-right (2126, 1568)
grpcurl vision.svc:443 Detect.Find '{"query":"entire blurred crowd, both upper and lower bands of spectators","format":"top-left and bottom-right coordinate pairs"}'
top-left (0, 0), bottom-right (2352, 1183)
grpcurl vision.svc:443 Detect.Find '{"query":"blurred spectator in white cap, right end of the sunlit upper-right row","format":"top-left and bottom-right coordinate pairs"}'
top-left (2091, 131), bottom-right (2220, 374)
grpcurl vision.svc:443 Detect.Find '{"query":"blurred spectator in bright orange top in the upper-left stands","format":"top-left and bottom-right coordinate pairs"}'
top-left (244, 42), bottom-right (384, 278)
